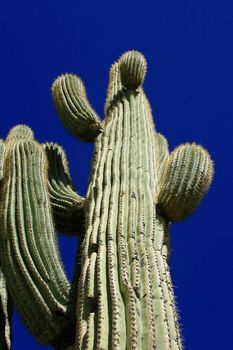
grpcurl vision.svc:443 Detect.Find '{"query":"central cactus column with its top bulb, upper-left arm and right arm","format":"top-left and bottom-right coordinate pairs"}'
top-left (53, 51), bottom-right (213, 350)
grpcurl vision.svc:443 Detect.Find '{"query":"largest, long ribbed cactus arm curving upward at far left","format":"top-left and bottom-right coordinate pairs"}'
top-left (0, 126), bottom-right (72, 345)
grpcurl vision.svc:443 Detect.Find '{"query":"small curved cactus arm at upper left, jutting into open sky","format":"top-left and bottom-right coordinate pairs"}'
top-left (52, 74), bottom-right (102, 142)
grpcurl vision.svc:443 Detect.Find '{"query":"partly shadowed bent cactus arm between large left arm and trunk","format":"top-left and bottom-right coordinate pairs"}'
top-left (43, 142), bottom-right (85, 234)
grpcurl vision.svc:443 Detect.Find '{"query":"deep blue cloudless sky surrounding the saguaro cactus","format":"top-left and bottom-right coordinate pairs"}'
top-left (0, 0), bottom-right (233, 350)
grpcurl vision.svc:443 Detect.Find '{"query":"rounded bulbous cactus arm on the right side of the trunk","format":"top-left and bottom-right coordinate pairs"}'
top-left (158, 143), bottom-right (213, 221)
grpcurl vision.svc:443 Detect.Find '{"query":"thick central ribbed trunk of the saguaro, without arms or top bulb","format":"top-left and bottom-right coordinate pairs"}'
top-left (77, 91), bottom-right (181, 350)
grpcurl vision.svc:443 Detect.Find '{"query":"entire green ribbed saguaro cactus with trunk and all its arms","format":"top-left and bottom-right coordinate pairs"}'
top-left (0, 51), bottom-right (213, 350)
